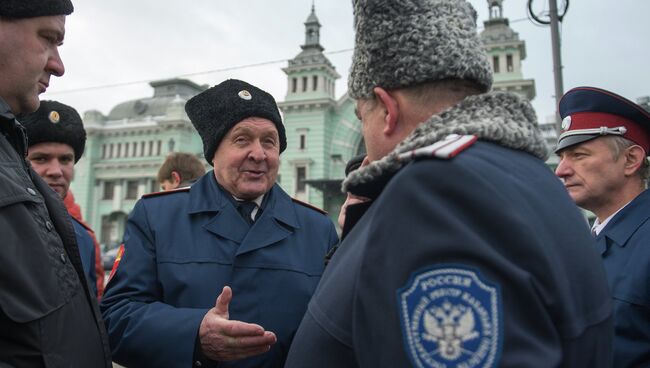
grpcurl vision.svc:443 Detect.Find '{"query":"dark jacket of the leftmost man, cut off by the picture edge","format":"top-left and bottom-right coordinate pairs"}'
top-left (0, 99), bottom-right (111, 367)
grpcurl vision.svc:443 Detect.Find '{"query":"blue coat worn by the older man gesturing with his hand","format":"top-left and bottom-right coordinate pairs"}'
top-left (101, 172), bottom-right (338, 367)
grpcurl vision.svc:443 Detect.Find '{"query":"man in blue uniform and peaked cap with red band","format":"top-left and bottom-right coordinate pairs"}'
top-left (555, 87), bottom-right (650, 367)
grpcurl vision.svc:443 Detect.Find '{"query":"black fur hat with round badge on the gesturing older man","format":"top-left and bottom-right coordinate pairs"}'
top-left (185, 79), bottom-right (287, 165)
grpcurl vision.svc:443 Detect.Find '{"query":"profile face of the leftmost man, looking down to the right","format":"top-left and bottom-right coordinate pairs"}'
top-left (0, 15), bottom-right (65, 114)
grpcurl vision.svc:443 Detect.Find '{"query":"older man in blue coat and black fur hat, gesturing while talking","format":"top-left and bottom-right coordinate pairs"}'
top-left (101, 80), bottom-right (338, 367)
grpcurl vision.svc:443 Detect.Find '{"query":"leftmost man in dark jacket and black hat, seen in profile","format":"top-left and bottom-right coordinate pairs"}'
top-left (0, 0), bottom-right (110, 367)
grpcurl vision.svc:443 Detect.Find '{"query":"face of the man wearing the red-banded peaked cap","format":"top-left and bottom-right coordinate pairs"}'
top-left (555, 138), bottom-right (625, 211)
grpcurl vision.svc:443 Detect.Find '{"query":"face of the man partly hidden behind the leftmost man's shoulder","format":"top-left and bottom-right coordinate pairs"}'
top-left (27, 142), bottom-right (74, 199)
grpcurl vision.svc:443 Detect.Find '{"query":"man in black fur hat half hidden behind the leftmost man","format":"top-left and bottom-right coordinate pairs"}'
top-left (18, 101), bottom-right (104, 298)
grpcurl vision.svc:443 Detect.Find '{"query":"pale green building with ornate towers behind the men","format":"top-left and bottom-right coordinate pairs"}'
top-left (71, 0), bottom-right (535, 248)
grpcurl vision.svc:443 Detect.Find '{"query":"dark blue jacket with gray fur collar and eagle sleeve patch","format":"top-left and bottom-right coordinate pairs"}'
top-left (286, 93), bottom-right (612, 368)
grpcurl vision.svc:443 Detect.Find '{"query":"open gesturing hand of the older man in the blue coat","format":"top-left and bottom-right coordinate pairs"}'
top-left (199, 286), bottom-right (277, 361)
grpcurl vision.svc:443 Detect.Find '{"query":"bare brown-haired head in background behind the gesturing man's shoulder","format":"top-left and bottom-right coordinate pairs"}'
top-left (158, 152), bottom-right (205, 191)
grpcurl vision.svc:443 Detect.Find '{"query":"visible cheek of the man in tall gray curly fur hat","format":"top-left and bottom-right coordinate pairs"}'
top-left (355, 100), bottom-right (395, 162)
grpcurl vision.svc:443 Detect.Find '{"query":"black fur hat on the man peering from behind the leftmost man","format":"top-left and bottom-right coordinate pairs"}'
top-left (18, 101), bottom-right (86, 163)
